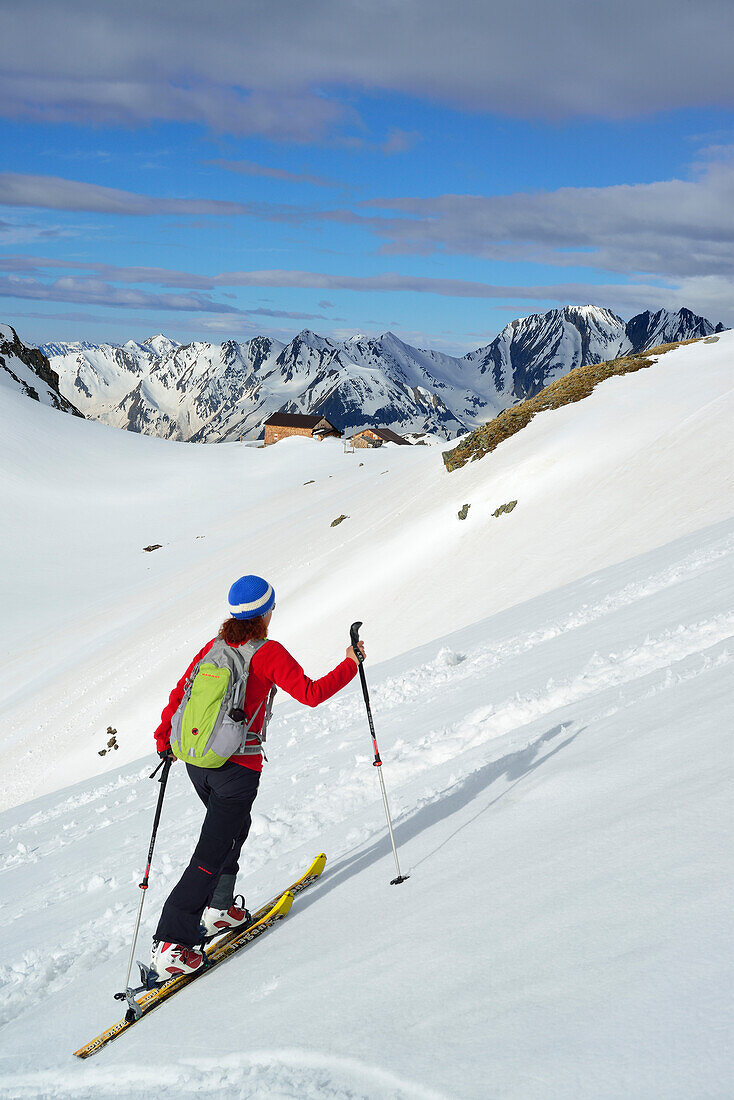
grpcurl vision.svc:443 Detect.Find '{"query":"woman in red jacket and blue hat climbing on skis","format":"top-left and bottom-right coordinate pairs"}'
top-left (151, 575), bottom-right (364, 981)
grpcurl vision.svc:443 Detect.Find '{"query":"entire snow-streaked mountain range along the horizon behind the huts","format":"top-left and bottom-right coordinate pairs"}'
top-left (43, 306), bottom-right (723, 442)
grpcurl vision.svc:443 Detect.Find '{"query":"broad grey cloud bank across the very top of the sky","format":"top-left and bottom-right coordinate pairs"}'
top-left (0, 0), bottom-right (734, 141)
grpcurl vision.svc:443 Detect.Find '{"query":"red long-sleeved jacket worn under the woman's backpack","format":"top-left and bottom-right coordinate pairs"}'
top-left (154, 638), bottom-right (357, 771)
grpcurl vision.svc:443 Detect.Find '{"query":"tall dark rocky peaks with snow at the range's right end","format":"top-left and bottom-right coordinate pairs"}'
top-left (465, 306), bottom-right (724, 407)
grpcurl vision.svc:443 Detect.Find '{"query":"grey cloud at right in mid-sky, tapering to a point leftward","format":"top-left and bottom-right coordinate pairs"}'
top-left (330, 158), bottom-right (734, 278)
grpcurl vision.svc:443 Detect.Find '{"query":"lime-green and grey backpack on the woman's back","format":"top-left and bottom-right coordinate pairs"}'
top-left (171, 639), bottom-right (275, 768)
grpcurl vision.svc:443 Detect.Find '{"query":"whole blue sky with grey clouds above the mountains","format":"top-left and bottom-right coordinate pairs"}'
top-left (0, 0), bottom-right (734, 353)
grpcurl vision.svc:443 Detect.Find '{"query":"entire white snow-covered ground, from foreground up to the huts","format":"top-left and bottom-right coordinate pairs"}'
top-left (0, 333), bottom-right (734, 1100)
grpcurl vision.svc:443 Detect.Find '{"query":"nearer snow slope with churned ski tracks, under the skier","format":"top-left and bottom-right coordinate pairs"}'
top-left (0, 523), bottom-right (734, 1100)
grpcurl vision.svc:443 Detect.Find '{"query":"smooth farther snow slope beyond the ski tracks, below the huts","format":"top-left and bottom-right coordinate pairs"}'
top-left (0, 332), bottom-right (734, 805)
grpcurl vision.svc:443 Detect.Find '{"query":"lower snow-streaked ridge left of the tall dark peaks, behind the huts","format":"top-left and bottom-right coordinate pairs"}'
top-left (46, 330), bottom-right (497, 442)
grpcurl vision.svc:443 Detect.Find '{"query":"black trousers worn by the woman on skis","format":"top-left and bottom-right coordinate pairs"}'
top-left (155, 760), bottom-right (260, 947)
